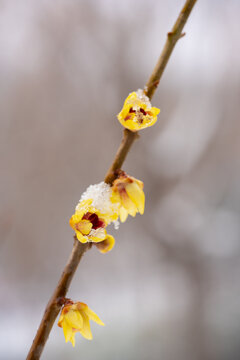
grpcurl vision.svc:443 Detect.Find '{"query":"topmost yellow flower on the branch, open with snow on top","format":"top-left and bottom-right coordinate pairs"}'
top-left (117, 89), bottom-right (160, 131)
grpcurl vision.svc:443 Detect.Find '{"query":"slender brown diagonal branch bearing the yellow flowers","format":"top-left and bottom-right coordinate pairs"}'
top-left (27, 0), bottom-right (197, 360)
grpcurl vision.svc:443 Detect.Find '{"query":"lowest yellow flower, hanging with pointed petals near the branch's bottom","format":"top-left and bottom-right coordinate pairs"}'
top-left (58, 300), bottom-right (104, 346)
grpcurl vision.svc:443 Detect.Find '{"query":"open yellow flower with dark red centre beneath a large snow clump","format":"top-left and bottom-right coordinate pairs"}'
top-left (69, 199), bottom-right (107, 243)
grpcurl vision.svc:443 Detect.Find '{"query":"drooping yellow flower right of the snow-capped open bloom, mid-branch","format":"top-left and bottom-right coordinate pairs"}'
top-left (111, 171), bottom-right (145, 222)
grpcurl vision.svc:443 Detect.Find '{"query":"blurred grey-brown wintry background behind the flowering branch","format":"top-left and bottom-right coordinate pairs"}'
top-left (0, 0), bottom-right (240, 360)
